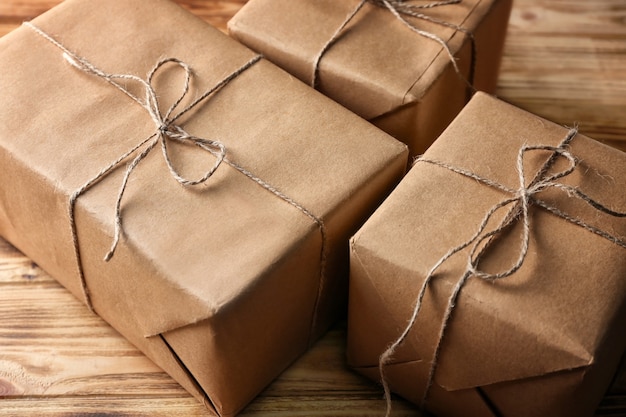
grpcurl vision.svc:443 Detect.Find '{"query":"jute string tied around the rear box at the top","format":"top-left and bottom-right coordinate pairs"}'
top-left (310, 0), bottom-right (476, 92)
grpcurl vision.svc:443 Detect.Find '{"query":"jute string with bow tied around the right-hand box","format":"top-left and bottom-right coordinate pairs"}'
top-left (379, 129), bottom-right (626, 416)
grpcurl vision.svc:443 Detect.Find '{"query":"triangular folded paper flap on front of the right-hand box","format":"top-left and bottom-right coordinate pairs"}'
top-left (435, 283), bottom-right (594, 391)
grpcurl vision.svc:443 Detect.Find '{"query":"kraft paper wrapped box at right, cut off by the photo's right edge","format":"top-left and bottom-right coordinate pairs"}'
top-left (348, 93), bottom-right (626, 417)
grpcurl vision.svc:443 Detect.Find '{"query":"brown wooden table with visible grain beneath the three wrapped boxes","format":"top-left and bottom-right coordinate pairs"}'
top-left (0, 0), bottom-right (626, 417)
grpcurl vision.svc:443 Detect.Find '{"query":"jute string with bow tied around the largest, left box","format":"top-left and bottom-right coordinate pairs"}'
top-left (24, 22), bottom-right (327, 330)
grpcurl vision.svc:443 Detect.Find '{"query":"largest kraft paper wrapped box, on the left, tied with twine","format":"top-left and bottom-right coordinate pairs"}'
top-left (0, 0), bottom-right (407, 416)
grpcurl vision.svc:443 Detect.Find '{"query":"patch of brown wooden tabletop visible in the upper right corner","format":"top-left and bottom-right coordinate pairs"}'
top-left (498, 0), bottom-right (626, 150)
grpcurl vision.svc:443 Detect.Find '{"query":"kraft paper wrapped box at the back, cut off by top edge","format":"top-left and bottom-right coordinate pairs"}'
top-left (228, 0), bottom-right (512, 155)
